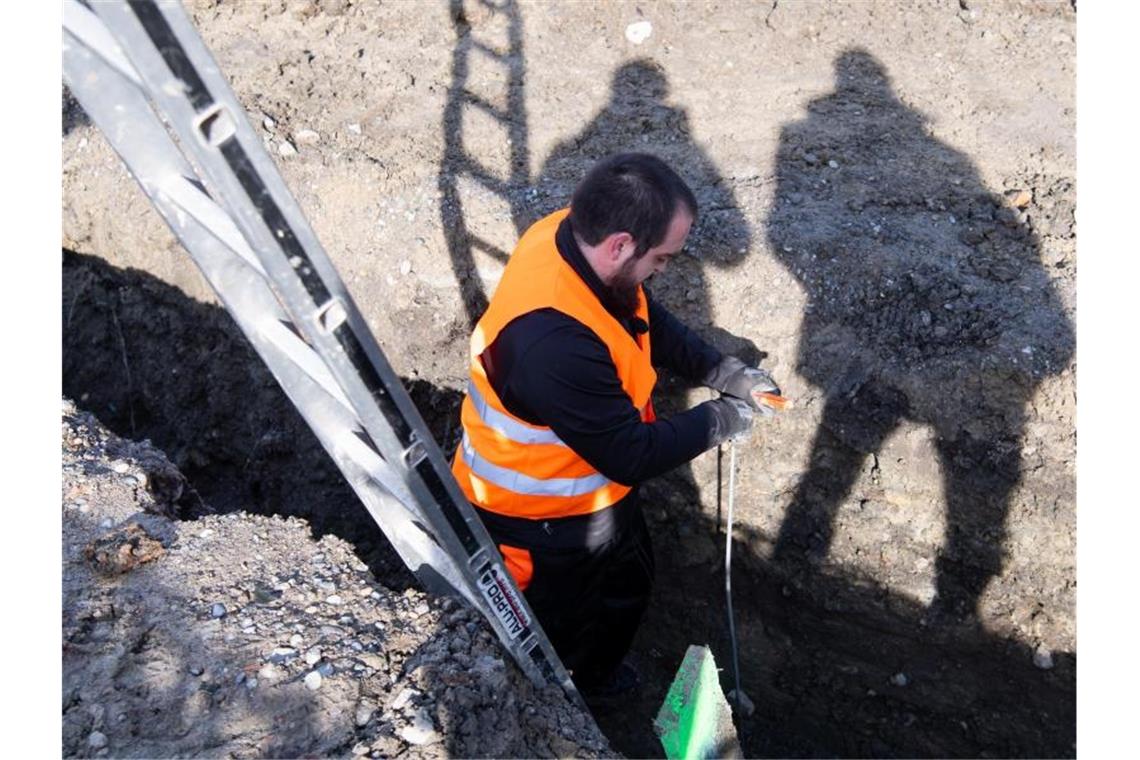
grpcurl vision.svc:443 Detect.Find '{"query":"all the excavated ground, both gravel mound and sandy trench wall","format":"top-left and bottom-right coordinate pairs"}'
top-left (62, 0), bottom-right (1076, 757)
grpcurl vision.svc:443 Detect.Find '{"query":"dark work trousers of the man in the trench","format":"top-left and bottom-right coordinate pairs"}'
top-left (477, 492), bottom-right (654, 689)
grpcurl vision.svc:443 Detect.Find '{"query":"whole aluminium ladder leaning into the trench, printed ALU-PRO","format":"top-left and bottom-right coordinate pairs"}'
top-left (64, 0), bottom-right (584, 705)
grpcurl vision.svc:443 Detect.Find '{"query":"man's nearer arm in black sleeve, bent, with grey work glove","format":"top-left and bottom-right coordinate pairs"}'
top-left (483, 310), bottom-right (747, 484)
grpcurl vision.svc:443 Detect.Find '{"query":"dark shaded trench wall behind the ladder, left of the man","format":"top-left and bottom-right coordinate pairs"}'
top-left (62, 250), bottom-right (462, 589)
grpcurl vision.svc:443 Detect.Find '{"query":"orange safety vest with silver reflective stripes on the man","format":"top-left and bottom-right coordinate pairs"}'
top-left (451, 209), bottom-right (657, 520)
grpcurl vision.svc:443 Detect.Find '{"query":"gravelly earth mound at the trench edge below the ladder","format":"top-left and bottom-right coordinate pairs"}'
top-left (60, 402), bottom-right (613, 757)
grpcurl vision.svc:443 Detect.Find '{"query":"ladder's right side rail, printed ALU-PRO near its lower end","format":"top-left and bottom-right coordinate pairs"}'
top-left (67, 2), bottom-right (577, 696)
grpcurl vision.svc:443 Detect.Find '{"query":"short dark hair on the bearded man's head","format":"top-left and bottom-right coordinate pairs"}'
top-left (570, 153), bottom-right (697, 258)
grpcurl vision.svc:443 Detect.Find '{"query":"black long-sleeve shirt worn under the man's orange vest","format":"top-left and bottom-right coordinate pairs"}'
top-left (481, 214), bottom-right (722, 485)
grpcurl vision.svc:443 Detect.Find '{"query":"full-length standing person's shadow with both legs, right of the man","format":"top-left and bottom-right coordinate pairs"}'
top-left (767, 50), bottom-right (1074, 620)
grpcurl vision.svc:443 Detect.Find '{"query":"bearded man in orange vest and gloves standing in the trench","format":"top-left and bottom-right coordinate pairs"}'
top-left (453, 153), bottom-right (780, 698)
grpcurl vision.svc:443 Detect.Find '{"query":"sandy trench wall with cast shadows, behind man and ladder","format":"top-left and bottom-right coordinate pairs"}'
top-left (63, 0), bottom-right (1076, 757)
